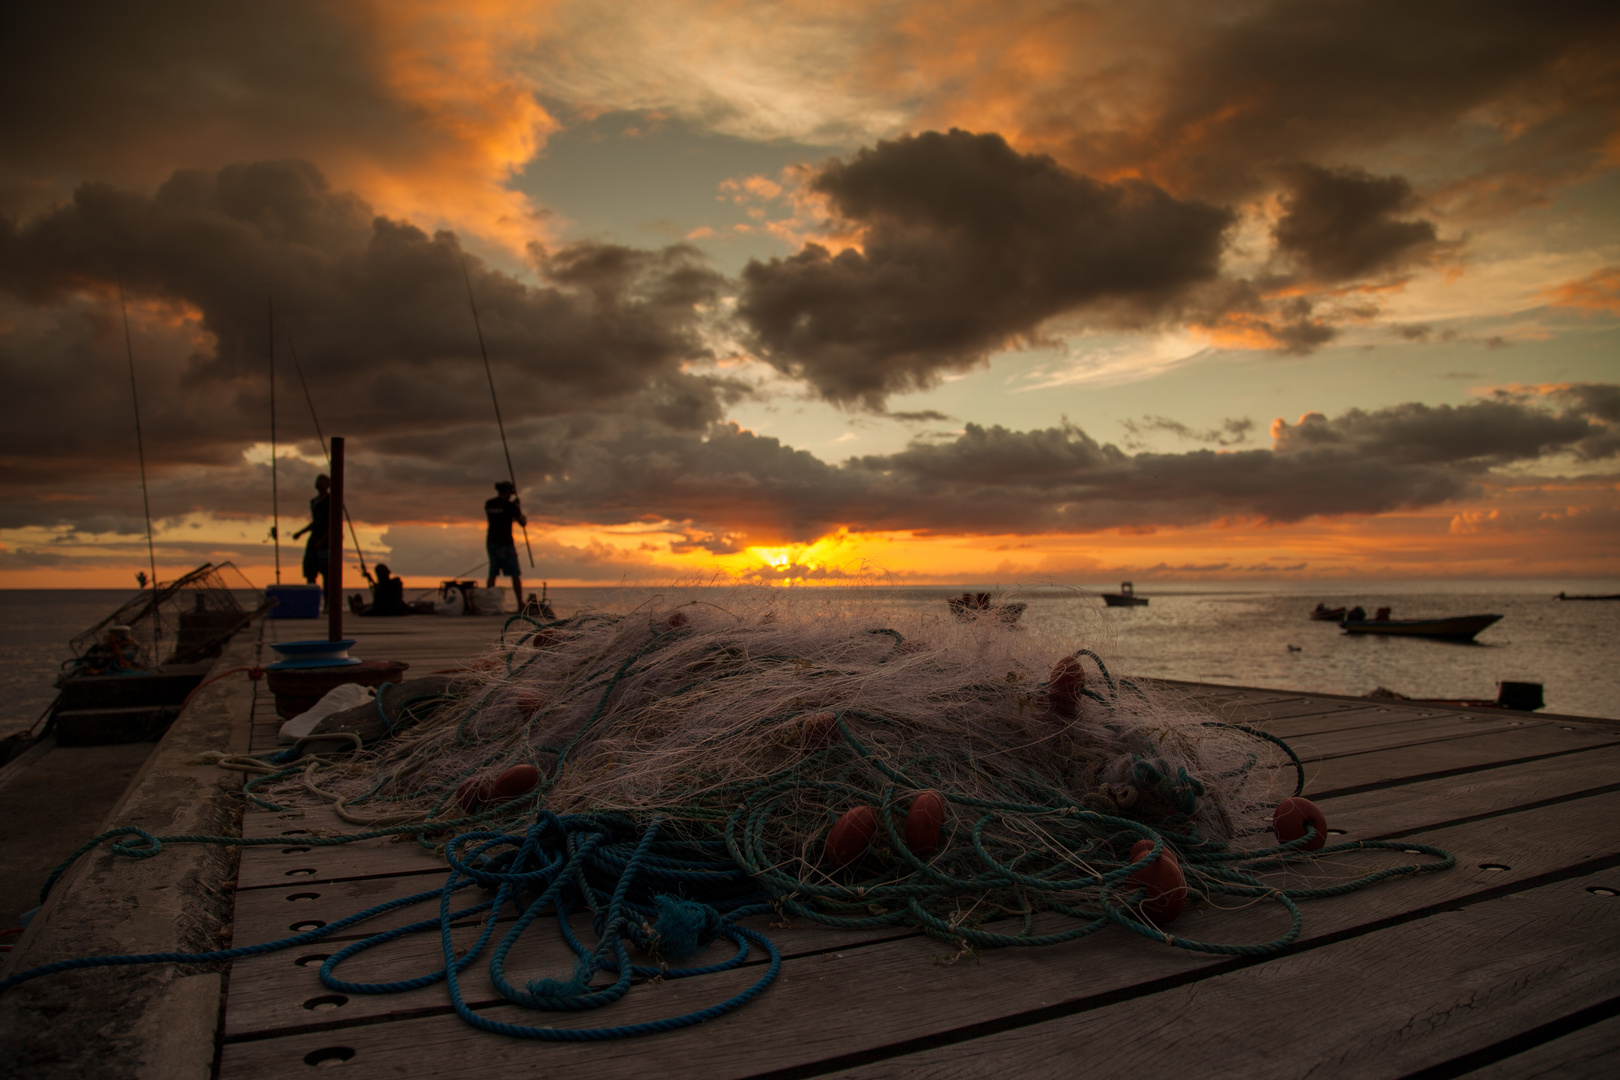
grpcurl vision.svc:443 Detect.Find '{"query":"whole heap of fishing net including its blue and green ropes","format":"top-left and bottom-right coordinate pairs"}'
top-left (0, 588), bottom-right (1455, 1041)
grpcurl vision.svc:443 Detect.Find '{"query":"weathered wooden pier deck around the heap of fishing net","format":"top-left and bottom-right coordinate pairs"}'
top-left (0, 619), bottom-right (1620, 1080)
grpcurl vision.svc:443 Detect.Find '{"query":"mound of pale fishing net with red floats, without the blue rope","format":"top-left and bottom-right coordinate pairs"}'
top-left (249, 588), bottom-right (1458, 950)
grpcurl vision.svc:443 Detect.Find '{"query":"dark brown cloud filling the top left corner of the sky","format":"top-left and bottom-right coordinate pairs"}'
top-left (0, 0), bottom-right (388, 212)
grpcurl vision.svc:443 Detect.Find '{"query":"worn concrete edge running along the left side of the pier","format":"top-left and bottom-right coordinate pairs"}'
top-left (0, 620), bottom-right (264, 1080)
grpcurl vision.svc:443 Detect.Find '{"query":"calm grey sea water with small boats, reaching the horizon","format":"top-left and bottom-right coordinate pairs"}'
top-left (0, 580), bottom-right (1620, 735)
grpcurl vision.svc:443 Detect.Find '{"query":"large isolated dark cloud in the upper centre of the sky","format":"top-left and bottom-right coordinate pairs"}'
top-left (739, 130), bottom-right (1233, 408)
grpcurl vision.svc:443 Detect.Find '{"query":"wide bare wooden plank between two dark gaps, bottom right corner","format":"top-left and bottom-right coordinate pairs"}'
top-left (833, 870), bottom-right (1620, 1080)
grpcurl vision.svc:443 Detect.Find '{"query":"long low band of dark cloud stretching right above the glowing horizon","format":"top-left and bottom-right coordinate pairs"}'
top-left (476, 387), bottom-right (1617, 540)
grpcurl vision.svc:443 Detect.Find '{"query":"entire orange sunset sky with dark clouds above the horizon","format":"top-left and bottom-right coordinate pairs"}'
top-left (0, 0), bottom-right (1620, 588)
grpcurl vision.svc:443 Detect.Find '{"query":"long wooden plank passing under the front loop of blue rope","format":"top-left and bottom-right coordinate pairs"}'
top-left (212, 793), bottom-right (1620, 1078)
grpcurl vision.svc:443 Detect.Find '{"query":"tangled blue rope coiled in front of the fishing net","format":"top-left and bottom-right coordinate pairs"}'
top-left (0, 810), bottom-right (782, 1041)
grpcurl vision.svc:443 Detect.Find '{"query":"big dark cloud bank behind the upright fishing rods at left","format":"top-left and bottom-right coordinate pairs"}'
top-left (0, 162), bottom-right (725, 520)
